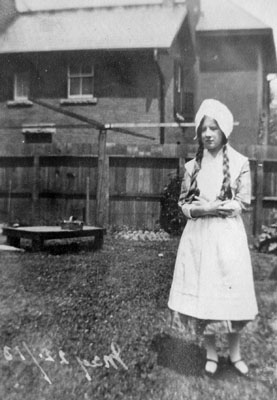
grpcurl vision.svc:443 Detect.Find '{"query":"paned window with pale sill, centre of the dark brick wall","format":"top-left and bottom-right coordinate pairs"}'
top-left (67, 63), bottom-right (94, 98)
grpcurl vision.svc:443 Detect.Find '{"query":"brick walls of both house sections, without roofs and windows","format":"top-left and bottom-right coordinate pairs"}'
top-left (0, 33), bottom-right (264, 149)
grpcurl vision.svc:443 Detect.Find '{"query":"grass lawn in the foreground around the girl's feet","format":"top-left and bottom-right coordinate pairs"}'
top-left (0, 235), bottom-right (277, 400)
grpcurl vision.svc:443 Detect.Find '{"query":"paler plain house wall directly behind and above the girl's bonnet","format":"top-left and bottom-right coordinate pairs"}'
top-left (195, 37), bottom-right (263, 146)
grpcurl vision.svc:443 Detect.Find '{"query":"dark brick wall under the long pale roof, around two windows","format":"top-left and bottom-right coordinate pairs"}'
top-left (0, 51), bottom-right (164, 144)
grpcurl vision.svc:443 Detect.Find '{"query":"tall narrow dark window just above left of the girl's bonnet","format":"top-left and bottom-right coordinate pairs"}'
top-left (174, 63), bottom-right (194, 122)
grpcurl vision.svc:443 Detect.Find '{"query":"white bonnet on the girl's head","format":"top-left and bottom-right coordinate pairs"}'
top-left (195, 99), bottom-right (234, 139)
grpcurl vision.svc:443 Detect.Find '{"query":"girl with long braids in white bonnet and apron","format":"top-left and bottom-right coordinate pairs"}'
top-left (168, 99), bottom-right (258, 375)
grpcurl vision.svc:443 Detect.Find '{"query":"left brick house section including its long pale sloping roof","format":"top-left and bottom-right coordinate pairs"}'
top-left (0, 0), bottom-right (199, 147)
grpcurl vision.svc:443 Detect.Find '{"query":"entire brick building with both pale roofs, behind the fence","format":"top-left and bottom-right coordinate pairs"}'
top-left (0, 0), bottom-right (276, 144)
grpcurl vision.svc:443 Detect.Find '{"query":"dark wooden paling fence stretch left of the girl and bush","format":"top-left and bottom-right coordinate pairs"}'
top-left (0, 145), bottom-right (179, 228)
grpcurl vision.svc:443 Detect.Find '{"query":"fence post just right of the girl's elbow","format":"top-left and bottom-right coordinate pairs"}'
top-left (254, 158), bottom-right (264, 235)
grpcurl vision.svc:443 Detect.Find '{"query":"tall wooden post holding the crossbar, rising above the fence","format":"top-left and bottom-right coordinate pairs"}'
top-left (95, 129), bottom-right (109, 227)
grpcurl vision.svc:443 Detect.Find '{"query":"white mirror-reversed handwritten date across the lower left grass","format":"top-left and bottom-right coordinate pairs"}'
top-left (3, 342), bottom-right (128, 385)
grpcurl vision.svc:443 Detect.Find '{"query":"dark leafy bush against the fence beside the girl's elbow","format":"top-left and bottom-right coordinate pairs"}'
top-left (161, 175), bottom-right (186, 235)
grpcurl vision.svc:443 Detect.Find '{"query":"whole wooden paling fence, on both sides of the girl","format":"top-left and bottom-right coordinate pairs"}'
top-left (0, 139), bottom-right (277, 234)
